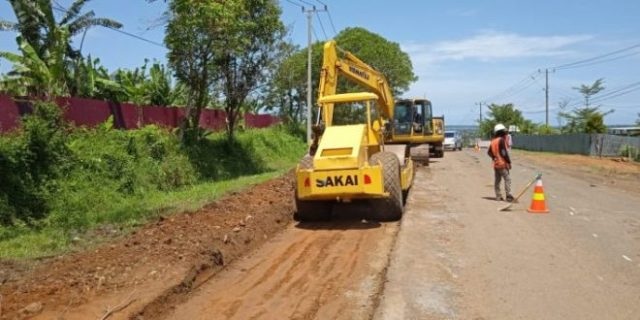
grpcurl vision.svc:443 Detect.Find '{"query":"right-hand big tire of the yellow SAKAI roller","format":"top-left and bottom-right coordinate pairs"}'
top-left (369, 152), bottom-right (404, 221)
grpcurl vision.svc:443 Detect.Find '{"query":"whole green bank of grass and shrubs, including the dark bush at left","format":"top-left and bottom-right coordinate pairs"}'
top-left (0, 103), bottom-right (306, 258)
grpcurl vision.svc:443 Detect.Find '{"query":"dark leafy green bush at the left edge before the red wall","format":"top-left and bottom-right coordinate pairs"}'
top-left (0, 102), bottom-right (70, 225)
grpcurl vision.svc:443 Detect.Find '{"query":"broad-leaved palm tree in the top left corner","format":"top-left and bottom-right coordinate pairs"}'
top-left (0, 0), bottom-right (122, 96)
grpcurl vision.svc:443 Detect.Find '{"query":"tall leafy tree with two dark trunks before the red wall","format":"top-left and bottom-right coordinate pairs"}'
top-left (165, 0), bottom-right (284, 138)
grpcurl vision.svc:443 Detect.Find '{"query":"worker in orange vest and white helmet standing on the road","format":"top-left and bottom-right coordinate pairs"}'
top-left (487, 123), bottom-right (513, 202)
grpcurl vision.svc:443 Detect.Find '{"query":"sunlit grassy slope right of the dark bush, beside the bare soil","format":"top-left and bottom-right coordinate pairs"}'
top-left (0, 121), bottom-right (306, 259)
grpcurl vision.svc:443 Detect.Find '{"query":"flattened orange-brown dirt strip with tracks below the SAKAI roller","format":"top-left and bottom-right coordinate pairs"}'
top-left (166, 220), bottom-right (398, 319)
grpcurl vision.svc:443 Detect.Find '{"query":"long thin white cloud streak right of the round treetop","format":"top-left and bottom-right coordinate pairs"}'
top-left (402, 31), bottom-right (593, 65)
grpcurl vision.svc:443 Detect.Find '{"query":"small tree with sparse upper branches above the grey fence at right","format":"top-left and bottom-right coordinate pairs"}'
top-left (558, 78), bottom-right (614, 133)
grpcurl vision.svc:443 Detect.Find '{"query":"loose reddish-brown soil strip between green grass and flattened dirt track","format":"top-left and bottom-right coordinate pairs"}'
top-left (0, 175), bottom-right (294, 319)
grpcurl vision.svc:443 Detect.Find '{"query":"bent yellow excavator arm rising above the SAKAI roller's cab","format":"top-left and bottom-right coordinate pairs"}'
top-left (319, 40), bottom-right (394, 126)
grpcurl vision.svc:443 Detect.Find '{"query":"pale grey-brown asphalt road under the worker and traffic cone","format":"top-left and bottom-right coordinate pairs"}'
top-left (374, 150), bottom-right (640, 320)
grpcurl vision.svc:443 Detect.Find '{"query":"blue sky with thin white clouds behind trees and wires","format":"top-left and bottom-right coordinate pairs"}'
top-left (0, 0), bottom-right (640, 125)
